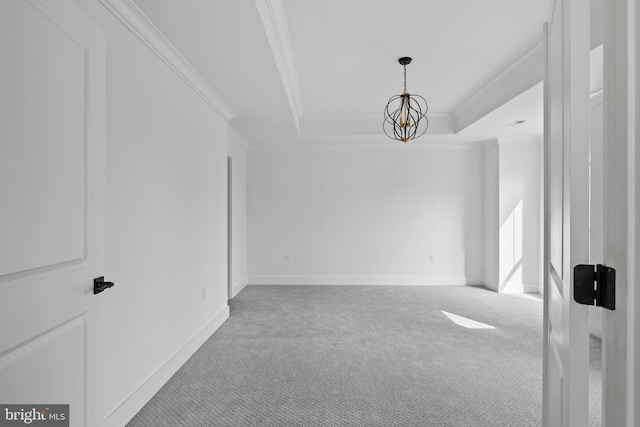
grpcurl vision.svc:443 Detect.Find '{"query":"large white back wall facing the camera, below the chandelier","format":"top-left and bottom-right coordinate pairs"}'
top-left (248, 147), bottom-right (483, 285)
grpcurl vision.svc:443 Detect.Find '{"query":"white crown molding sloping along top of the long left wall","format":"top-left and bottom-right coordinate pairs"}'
top-left (99, 0), bottom-right (236, 122)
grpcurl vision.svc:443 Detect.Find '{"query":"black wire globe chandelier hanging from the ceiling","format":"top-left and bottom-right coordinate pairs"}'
top-left (382, 56), bottom-right (429, 142)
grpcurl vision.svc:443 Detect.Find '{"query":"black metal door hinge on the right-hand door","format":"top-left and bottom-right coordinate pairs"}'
top-left (573, 264), bottom-right (616, 310)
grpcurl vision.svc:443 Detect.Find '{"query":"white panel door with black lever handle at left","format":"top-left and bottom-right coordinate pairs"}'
top-left (0, 0), bottom-right (105, 427)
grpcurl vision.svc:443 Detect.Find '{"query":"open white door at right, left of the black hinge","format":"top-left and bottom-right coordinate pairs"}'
top-left (543, 0), bottom-right (589, 427)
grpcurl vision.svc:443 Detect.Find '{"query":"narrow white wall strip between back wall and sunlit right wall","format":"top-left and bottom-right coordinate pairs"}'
top-left (483, 139), bottom-right (500, 292)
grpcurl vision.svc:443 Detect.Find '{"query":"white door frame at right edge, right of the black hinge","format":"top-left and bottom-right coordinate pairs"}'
top-left (602, 0), bottom-right (640, 427)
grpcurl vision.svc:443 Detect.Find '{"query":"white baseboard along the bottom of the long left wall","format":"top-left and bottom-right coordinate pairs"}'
top-left (104, 306), bottom-right (229, 427)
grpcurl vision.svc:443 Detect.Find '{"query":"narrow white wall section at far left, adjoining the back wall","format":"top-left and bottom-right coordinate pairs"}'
top-left (228, 132), bottom-right (247, 297)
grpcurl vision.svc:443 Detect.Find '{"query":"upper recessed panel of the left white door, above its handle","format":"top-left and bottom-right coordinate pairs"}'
top-left (0, 1), bottom-right (86, 275)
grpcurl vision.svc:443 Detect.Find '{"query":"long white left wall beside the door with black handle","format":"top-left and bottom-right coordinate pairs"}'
top-left (77, 0), bottom-right (228, 426)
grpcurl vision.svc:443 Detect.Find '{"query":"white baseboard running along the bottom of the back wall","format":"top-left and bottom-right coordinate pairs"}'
top-left (248, 276), bottom-right (480, 286)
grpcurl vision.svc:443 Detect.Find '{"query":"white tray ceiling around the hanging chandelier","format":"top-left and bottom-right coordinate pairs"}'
top-left (135, 0), bottom-right (548, 148)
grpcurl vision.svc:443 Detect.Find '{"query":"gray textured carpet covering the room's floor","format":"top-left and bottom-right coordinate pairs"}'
top-left (128, 286), bottom-right (542, 427)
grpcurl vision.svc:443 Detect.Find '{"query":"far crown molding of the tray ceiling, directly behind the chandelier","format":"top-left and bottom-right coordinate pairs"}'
top-left (300, 113), bottom-right (455, 135)
